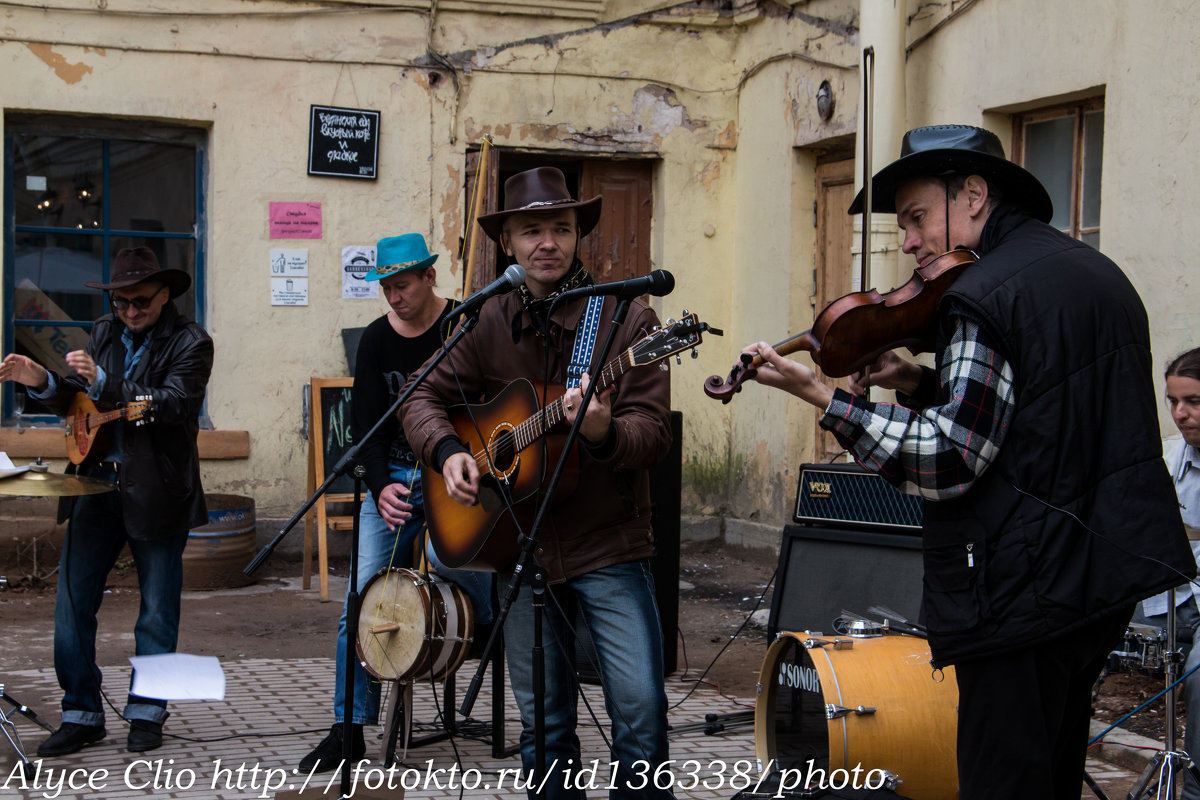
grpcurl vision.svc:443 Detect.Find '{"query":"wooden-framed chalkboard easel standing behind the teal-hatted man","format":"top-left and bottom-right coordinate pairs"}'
top-left (301, 378), bottom-right (354, 602)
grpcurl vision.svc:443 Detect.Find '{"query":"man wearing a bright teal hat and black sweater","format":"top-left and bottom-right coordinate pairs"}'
top-left (300, 234), bottom-right (492, 774)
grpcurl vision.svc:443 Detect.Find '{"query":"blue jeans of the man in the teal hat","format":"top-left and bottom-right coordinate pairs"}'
top-left (334, 464), bottom-right (492, 724)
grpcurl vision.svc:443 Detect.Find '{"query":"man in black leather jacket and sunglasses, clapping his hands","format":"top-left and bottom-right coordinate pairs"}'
top-left (0, 247), bottom-right (212, 756)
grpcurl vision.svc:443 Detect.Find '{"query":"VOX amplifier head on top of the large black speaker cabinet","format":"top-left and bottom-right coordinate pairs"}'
top-left (792, 464), bottom-right (924, 535)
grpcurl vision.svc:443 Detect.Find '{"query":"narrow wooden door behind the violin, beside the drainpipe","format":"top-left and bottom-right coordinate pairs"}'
top-left (812, 158), bottom-right (854, 461)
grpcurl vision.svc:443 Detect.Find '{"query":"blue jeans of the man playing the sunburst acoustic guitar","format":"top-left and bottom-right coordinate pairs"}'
top-left (504, 560), bottom-right (671, 800)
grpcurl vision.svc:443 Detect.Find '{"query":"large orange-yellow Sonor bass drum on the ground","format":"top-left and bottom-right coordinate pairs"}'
top-left (755, 631), bottom-right (959, 800)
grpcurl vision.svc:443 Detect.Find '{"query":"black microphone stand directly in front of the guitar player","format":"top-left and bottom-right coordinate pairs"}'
top-left (458, 297), bottom-right (630, 796)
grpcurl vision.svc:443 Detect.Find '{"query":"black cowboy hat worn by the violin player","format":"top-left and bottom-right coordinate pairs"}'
top-left (850, 125), bottom-right (1054, 222)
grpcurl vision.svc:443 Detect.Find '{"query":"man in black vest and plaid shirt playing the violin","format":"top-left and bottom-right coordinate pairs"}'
top-left (745, 125), bottom-right (1196, 800)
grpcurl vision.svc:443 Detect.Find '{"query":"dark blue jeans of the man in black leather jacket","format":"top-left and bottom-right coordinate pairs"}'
top-left (54, 471), bottom-right (187, 726)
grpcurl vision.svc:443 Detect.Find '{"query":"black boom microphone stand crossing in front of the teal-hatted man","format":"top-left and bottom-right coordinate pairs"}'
top-left (242, 303), bottom-right (482, 798)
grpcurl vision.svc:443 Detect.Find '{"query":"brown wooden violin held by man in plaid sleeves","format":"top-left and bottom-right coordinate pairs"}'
top-left (704, 248), bottom-right (978, 403)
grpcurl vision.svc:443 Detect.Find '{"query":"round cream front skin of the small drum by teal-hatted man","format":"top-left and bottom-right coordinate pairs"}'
top-left (356, 569), bottom-right (430, 680)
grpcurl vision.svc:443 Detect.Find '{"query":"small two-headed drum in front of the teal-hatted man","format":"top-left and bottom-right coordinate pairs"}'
top-left (356, 567), bottom-right (475, 681)
